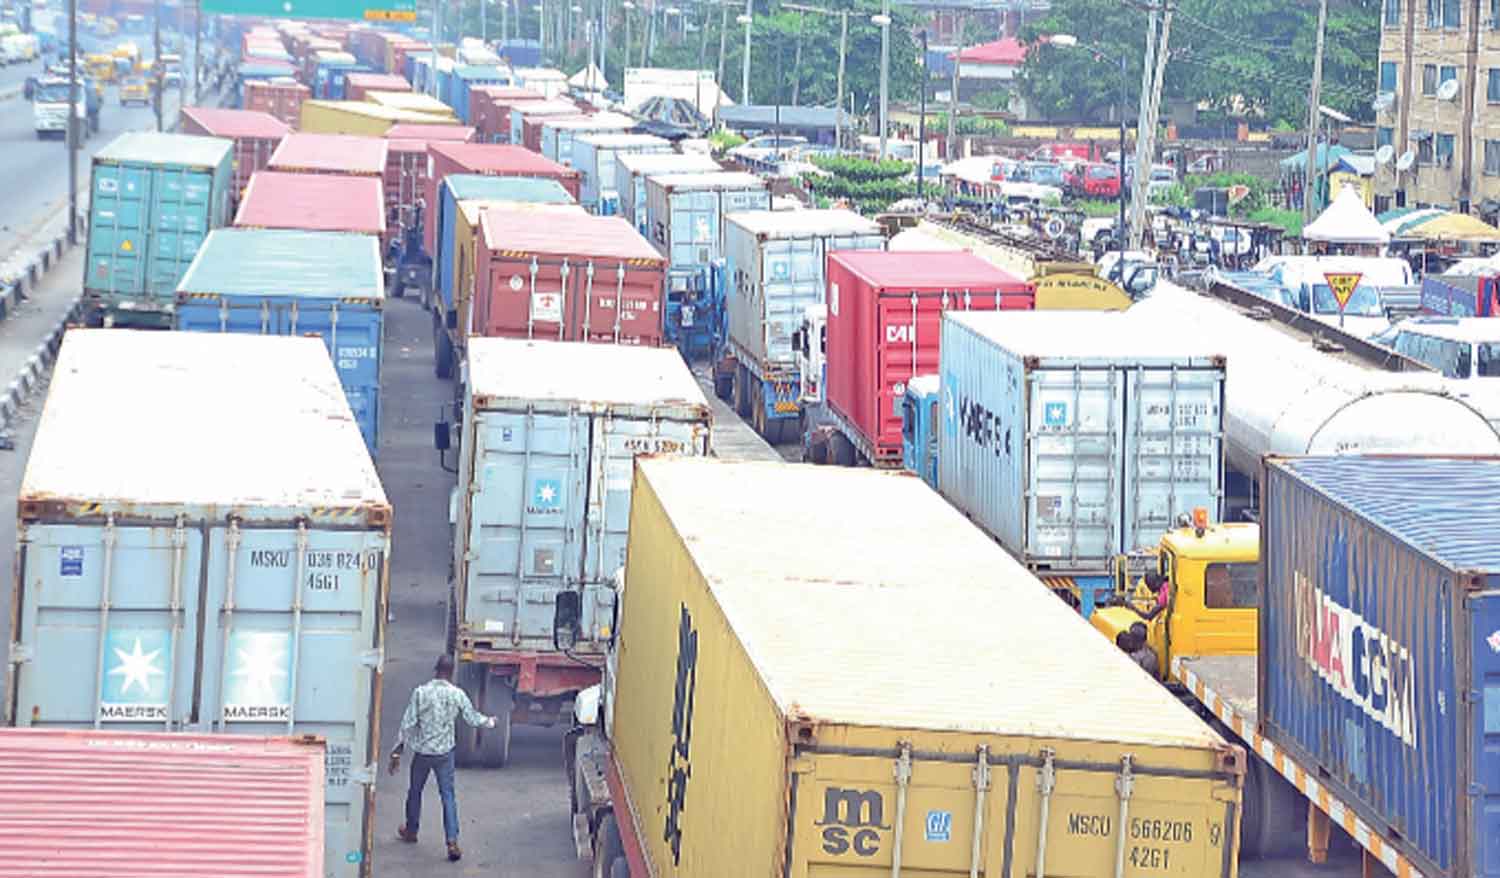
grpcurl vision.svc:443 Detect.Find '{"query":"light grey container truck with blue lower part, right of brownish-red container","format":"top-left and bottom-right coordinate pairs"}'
top-left (645, 171), bottom-right (771, 360)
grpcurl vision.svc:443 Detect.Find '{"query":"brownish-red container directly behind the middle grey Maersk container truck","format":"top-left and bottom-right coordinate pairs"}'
top-left (473, 207), bottom-right (666, 347)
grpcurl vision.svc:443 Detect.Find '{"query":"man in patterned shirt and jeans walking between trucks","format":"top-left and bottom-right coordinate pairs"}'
top-left (390, 653), bottom-right (495, 860)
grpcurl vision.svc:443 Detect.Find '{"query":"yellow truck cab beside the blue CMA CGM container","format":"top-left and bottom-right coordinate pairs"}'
top-left (1089, 510), bottom-right (1260, 680)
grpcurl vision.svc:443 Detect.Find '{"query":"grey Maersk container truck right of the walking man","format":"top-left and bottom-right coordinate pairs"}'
top-left (435, 338), bottom-right (711, 767)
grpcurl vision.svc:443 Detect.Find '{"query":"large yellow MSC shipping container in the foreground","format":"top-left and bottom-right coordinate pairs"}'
top-left (611, 459), bottom-right (1245, 878)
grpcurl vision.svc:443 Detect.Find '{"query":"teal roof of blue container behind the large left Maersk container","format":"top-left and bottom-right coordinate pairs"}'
top-left (177, 228), bottom-right (386, 302)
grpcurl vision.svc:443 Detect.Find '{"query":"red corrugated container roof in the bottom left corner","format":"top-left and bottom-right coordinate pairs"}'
top-left (0, 728), bottom-right (324, 878)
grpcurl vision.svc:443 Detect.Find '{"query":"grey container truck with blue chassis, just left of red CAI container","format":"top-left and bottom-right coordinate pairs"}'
top-left (714, 210), bottom-right (885, 444)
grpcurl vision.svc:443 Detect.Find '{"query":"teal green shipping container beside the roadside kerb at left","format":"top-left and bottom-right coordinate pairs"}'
top-left (84, 132), bottom-right (234, 326)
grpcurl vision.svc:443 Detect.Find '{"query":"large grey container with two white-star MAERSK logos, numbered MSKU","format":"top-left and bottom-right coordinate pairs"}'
top-left (6, 328), bottom-right (392, 878)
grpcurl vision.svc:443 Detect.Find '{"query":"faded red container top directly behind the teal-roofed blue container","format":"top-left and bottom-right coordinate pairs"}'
top-left (234, 171), bottom-right (386, 236)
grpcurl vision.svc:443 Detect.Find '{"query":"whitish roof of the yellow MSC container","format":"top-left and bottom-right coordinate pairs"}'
top-left (627, 458), bottom-right (1223, 747)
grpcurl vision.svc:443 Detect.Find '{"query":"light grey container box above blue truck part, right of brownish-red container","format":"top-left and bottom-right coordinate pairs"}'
top-left (645, 171), bottom-right (771, 269)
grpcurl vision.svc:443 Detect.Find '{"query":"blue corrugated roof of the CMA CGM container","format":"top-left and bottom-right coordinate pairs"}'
top-left (1271, 455), bottom-right (1500, 573)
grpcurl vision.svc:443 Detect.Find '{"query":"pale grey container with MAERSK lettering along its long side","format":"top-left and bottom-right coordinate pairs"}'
top-left (936, 311), bottom-right (1226, 614)
